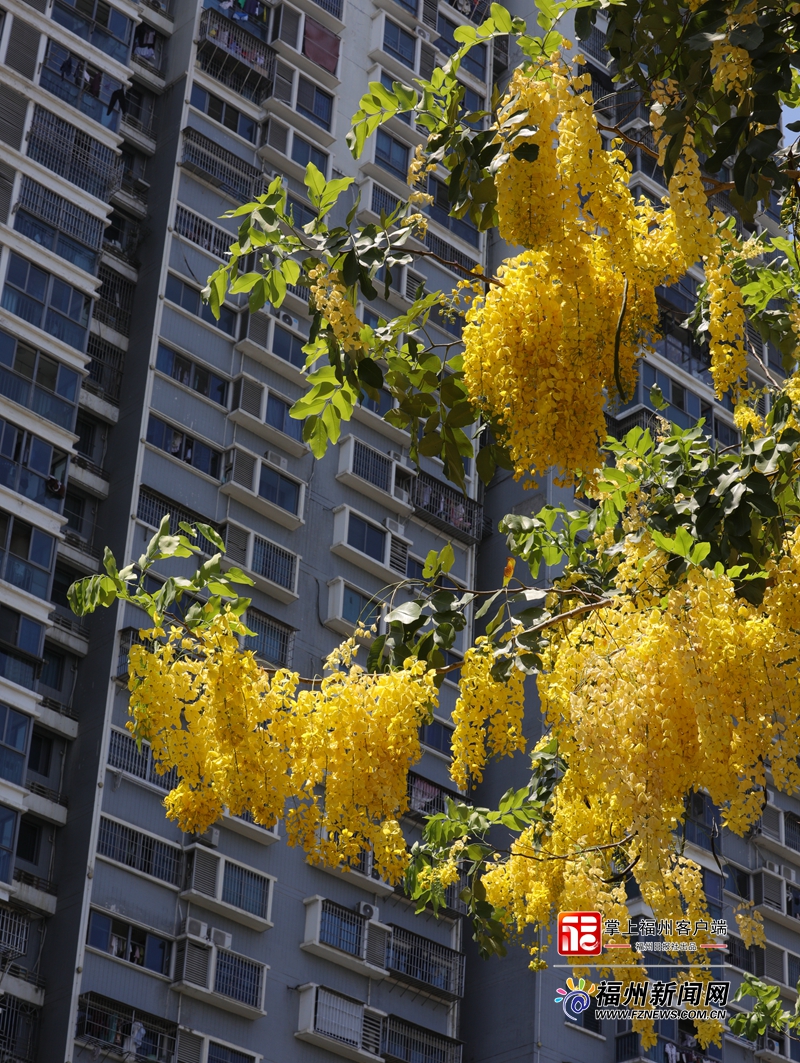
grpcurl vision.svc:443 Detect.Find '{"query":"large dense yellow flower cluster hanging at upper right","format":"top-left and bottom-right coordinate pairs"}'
top-left (463, 60), bottom-right (745, 483)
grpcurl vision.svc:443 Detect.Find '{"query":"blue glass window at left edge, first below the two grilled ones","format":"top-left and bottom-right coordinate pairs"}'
top-left (3, 253), bottom-right (91, 351)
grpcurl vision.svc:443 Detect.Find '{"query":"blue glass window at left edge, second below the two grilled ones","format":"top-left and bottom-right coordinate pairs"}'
top-left (0, 330), bottom-right (80, 428)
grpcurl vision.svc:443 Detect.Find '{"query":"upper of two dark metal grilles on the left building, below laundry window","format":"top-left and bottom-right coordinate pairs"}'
top-left (28, 104), bottom-right (122, 199)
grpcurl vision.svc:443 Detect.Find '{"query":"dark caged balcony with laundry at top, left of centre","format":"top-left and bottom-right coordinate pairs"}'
top-left (198, 10), bottom-right (275, 104)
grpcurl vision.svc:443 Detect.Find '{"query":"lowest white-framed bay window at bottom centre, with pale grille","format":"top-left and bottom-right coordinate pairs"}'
top-left (294, 983), bottom-right (384, 1063)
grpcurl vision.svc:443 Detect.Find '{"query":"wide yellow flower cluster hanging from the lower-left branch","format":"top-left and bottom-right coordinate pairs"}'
top-left (129, 615), bottom-right (437, 882)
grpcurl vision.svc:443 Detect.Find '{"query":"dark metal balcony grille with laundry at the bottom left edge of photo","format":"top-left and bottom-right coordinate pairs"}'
top-left (75, 993), bottom-right (177, 1063)
